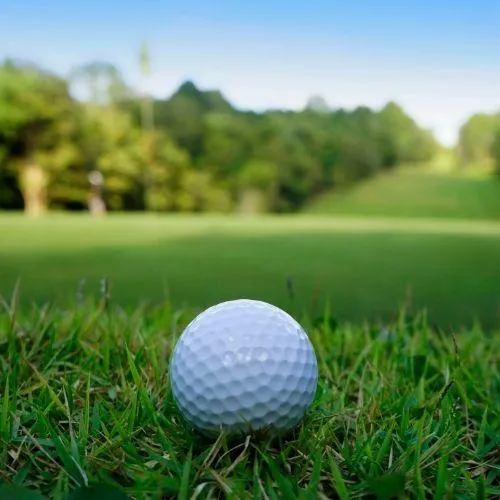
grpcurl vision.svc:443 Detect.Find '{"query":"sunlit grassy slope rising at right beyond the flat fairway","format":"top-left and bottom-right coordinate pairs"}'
top-left (306, 168), bottom-right (500, 220)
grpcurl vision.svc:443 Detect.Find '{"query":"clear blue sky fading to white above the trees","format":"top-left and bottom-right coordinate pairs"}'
top-left (0, 0), bottom-right (500, 145)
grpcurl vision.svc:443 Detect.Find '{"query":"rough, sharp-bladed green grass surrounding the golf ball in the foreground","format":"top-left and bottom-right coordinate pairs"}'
top-left (0, 295), bottom-right (500, 500)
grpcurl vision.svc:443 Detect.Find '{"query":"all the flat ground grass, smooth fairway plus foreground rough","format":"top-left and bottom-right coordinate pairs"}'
top-left (0, 215), bottom-right (500, 500)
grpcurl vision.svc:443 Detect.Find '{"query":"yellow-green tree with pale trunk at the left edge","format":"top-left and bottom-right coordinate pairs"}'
top-left (0, 61), bottom-right (77, 215)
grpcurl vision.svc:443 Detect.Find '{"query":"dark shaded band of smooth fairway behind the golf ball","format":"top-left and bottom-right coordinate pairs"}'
top-left (0, 228), bottom-right (500, 327)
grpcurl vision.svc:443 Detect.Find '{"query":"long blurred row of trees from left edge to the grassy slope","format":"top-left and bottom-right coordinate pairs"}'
top-left (0, 60), bottom-right (439, 213)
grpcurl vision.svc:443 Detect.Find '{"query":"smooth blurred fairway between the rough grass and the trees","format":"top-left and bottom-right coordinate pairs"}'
top-left (0, 215), bottom-right (500, 327)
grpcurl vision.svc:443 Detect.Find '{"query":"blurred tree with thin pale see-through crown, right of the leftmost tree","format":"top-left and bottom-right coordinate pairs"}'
top-left (69, 61), bottom-right (144, 213)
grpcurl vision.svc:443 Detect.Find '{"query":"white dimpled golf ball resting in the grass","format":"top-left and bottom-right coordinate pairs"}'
top-left (171, 299), bottom-right (318, 433)
